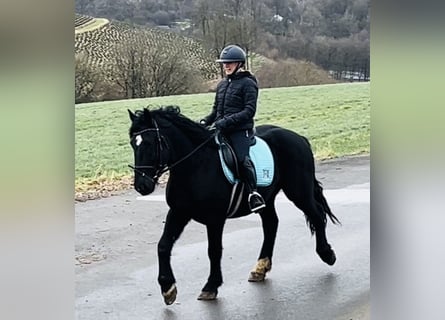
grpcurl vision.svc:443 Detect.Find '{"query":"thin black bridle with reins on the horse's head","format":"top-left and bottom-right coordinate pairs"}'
top-left (128, 119), bottom-right (215, 184)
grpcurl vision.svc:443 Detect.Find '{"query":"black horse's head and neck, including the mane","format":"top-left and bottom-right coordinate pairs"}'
top-left (128, 106), bottom-right (216, 195)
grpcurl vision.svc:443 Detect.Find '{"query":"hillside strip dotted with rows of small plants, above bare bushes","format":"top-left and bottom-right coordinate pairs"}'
top-left (74, 14), bottom-right (219, 80)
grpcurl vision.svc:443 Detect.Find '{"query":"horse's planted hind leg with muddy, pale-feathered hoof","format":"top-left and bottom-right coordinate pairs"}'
top-left (249, 199), bottom-right (278, 282)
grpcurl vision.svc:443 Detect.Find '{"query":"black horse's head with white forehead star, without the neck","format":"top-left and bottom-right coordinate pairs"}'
top-left (128, 108), bottom-right (168, 195)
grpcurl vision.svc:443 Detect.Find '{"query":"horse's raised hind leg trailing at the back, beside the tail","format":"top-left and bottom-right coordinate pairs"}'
top-left (283, 172), bottom-right (336, 265)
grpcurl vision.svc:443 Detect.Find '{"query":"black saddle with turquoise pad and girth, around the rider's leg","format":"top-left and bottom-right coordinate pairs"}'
top-left (215, 133), bottom-right (274, 218)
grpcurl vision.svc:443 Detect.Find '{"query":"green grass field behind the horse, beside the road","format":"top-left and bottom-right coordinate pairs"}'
top-left (75, 83), bottom-right (370, 194)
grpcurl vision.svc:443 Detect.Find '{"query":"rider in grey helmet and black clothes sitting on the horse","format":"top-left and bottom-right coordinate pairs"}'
top-left (200, 45), bottom-right (266, 213)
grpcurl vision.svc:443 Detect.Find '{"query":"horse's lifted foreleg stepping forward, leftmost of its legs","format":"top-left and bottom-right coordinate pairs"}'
top-left (158, 210), bottom-right (190, 305)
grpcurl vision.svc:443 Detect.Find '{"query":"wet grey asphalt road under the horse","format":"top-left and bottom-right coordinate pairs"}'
top-left (75, 156), bottom-right (370, 320)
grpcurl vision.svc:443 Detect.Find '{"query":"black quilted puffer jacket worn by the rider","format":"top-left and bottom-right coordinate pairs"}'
top-left (204, 71), bottom-right (258, 132)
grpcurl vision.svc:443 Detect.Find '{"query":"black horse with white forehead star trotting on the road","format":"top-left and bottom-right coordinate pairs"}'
top-left (128, 106), bottom-right (339, 305)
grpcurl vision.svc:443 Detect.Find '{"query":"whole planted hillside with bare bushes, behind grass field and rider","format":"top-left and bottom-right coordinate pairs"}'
top-left (75, 14), bottom-right (336, 103)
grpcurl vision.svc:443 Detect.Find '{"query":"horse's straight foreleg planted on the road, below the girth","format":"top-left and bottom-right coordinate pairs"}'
top-left (198, 222), bottom-right (224, 300)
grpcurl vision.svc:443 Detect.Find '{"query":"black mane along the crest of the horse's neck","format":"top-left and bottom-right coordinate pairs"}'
top-left (136, 105), bottom-right (211, 141)
